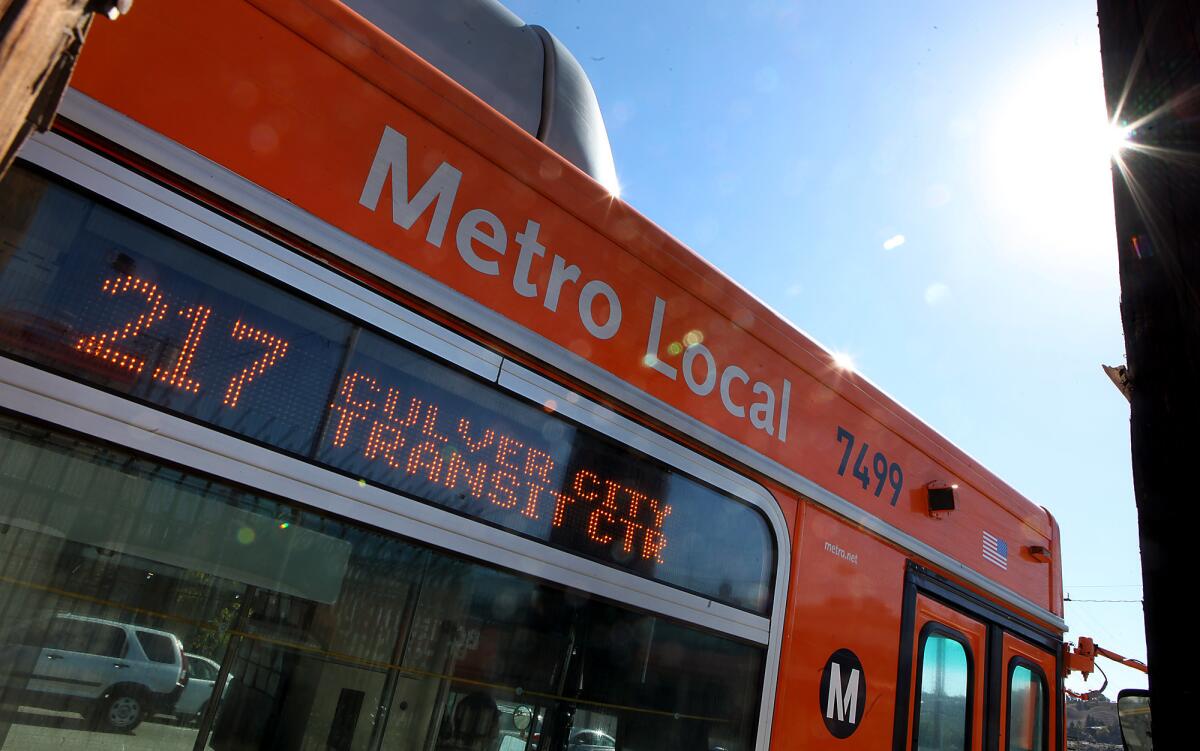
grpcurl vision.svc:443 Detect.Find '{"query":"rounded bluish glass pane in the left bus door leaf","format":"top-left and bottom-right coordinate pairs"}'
top-left (917, 631), bottom-right (971, 751)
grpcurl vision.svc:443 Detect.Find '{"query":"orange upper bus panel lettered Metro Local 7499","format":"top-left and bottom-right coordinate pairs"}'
top-left (65, 0), bottom-right (1061, 613)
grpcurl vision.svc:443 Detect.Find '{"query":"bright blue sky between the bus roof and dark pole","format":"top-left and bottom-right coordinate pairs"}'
top-left (505, 0), bottom-right (1146, 698)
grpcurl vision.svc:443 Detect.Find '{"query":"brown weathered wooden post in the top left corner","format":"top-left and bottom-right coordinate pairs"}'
top-left (0, 0), bottom-right (133, 176)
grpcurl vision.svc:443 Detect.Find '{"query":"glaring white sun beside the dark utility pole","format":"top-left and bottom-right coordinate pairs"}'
top-left (984, 44), bottom-right (1113, 265)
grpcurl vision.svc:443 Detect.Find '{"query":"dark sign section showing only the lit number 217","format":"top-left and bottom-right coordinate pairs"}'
top-left (0, 172), bottom-right (350, 452)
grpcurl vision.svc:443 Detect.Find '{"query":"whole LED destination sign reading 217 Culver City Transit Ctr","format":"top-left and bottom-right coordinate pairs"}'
top-left (0, 169), bottom-right (775, 612)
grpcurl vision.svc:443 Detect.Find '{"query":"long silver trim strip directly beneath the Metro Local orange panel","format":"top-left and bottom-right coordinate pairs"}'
top-left (49, 90), bottom-right (1067, 631)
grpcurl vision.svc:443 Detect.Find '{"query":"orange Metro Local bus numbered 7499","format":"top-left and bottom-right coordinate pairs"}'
top-left (0, 0), bottom-right (1066, 751)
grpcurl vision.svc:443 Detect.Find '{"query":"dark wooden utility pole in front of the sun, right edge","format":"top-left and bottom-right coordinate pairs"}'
top-left (1099, 0), bottom-right (1200, 749)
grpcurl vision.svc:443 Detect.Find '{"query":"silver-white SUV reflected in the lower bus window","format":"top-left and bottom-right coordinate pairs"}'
top-left (0, 613), bottom-right (187, 732)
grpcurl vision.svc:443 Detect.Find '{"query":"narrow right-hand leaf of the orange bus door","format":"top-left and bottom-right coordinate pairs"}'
top-left (1000, 632), bottom-right (1057, 751)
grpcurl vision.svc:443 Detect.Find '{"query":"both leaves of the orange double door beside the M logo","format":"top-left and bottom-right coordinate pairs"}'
top-left (895, 571), bottom-right (1062, 751)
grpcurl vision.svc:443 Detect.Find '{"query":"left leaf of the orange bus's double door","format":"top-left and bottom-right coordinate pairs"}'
top-left (905, 594), bottom-right (988, 751)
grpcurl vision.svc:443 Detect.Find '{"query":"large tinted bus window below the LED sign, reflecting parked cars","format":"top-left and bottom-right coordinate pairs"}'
top-left (0, 414), bottom-right (766, 751)
